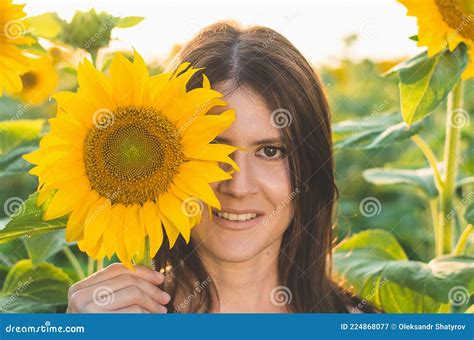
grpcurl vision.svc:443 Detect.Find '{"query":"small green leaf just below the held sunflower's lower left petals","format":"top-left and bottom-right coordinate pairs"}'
top-left (23, 230), bottom-right (66, 266)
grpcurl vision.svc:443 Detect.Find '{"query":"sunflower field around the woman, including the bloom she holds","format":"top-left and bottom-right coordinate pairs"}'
top-left (0, 0), bottom-right (474, 313)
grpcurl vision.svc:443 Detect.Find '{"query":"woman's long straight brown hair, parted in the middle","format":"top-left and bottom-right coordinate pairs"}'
top-left (155, 22), bottom-right (378, 313)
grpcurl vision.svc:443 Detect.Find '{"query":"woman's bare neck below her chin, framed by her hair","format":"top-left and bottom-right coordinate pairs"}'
top-left (198, 238), bottom-right (287, 313)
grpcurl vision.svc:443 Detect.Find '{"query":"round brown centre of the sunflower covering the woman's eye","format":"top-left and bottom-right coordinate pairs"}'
top-left (84, 106), bottom-right (185, 204)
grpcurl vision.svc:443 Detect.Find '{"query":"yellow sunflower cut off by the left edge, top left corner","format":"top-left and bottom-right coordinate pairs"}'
top-left (0, 0), bottom-right (34, 97)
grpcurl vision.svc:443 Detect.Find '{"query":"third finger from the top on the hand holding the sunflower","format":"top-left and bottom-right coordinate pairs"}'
top-left (84, 286), bottom-right (167, 313)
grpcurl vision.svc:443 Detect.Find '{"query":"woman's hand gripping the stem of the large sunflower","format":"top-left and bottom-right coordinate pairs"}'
top-left (67, 263), bottom-right (170, 313)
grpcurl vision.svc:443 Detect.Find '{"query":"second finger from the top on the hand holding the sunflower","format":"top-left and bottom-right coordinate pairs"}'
top-left (75, 273), bottom-right (171, 305)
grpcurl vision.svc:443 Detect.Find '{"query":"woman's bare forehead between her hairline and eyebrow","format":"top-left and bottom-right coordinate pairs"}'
top-left (210, 83), bottom-right (281, 146)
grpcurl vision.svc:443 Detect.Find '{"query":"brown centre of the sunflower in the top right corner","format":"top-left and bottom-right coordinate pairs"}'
top-left (435, 0), bottom-right (474, 40)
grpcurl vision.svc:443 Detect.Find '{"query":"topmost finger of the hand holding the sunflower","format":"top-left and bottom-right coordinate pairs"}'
top-left (68, 263), bottom-right (164, 299)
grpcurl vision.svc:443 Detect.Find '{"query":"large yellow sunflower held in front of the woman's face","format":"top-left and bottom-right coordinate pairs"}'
top-left (25, 53), bottom-right (238, 267)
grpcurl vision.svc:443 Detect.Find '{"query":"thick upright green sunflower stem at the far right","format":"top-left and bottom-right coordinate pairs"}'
top-left (439, 80), bottom-right (463, 254)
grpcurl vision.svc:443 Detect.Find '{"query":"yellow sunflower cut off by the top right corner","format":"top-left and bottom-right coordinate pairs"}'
top-left (398, 0), bottom-right (474, 79)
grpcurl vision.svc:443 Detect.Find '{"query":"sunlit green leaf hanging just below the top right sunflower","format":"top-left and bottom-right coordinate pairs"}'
top-left (388, 44), bottom-right (468, 126)
